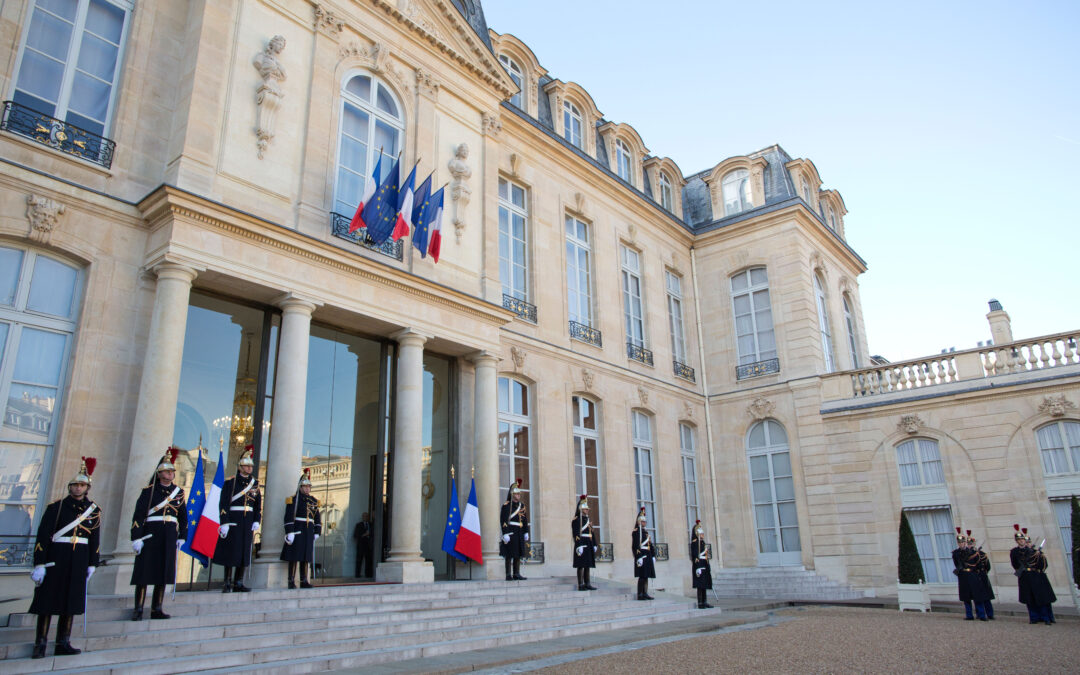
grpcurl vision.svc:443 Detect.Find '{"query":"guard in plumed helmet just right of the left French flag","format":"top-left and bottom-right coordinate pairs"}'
top-left (214, 445), bottom-right (262, 593)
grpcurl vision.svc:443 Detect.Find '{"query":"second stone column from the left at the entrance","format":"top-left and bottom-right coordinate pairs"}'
top-left (252, 294), bottom-right (318, 588)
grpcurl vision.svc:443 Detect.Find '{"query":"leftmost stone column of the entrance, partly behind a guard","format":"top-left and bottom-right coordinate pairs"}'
top-left (106, 262), bottom-right (199, 593)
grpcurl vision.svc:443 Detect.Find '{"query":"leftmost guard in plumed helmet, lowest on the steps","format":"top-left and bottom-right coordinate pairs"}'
top-left (30, 457), bottom-right (102, 659)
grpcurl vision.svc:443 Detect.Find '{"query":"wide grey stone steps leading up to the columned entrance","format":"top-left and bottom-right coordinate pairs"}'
top-left (0, 578), bottom-right (719, 675)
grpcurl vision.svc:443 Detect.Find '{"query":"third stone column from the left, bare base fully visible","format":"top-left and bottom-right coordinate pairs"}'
top-left (375, 328), bottom-right (435, 583)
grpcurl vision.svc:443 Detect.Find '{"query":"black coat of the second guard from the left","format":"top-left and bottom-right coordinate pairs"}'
top-left (132, 481), bottom-right (188, 586)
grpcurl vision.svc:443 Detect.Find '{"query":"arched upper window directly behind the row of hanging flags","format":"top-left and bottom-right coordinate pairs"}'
top-left (334, 75), bottom-right (405, 216)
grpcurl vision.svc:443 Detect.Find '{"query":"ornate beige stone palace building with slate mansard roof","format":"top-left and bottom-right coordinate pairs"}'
top-left (0, 0), bottom-right (1080, 612)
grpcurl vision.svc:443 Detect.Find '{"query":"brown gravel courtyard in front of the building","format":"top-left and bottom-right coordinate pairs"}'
top-left (535, 607), bottom-right (1080, 675)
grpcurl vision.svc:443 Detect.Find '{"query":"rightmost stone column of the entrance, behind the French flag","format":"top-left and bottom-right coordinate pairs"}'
top-left (469, 352), bottom-right (505, 579)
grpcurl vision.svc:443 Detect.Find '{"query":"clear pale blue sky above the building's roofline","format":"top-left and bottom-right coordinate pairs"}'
top-left (483, 0), bottom-right (1080, 361)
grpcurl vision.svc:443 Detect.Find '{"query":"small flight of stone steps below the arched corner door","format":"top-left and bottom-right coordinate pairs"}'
top-left (713, 567), bottom-right (864, 600)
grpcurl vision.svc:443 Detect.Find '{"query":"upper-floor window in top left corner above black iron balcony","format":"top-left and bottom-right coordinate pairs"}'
top-left (12, 0), bottom-right (132, 135)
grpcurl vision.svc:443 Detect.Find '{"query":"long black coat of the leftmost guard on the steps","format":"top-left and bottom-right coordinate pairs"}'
top-left (30, 497), bottom-right (102, 615)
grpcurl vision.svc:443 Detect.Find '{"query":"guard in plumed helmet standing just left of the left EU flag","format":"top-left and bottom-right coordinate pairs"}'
top-left (132, 447), bottom-right (188, 621)
